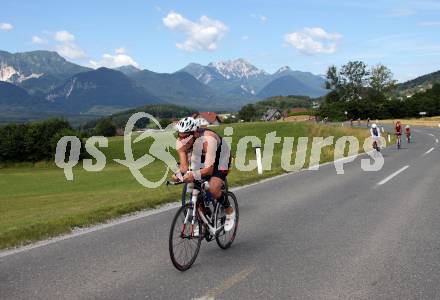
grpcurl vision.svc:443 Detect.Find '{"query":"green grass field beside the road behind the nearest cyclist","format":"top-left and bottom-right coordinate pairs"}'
top-left (0, 122), bottom-right (368, 249)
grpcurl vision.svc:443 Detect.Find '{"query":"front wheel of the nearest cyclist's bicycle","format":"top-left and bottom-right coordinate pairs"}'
top-left (169, 204), bottom-right (202, 271)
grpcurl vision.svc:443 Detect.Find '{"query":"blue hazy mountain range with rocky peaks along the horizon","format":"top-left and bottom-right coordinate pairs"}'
top-left (0, 51), bottom-right (438, 122)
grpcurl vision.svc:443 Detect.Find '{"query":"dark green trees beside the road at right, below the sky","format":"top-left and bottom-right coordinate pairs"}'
top-left (318, 61), bottom-right (440, 121)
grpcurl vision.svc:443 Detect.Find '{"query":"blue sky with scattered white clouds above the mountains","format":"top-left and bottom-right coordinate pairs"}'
top-left (0, 0), bottom-right (440, 81)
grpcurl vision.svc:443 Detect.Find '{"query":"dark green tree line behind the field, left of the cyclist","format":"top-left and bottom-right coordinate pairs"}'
top-left (0, 105), bottom-right (194, 165)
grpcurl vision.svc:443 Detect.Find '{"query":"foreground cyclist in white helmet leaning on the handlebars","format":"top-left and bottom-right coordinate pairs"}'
top-left (173, 117), bottom-right (235, 231)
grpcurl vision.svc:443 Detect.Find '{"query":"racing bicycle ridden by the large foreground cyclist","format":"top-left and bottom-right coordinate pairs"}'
top-left (166, 181), bottom-right (239, 271)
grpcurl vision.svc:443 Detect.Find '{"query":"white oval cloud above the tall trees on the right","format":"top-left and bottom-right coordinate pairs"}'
top-left (284, 27), bottom-right (342, 54)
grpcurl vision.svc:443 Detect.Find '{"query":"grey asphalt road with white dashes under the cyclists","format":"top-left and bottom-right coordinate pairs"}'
top-left (0, 128), bottom-right (440, 299)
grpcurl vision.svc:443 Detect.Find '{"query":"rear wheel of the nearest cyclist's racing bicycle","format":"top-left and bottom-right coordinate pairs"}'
top-left (215, 192), bottom-right (239, 250)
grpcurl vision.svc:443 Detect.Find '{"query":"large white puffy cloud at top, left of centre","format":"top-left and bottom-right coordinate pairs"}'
top-left (162, 12), bottom-right (229, 52)
